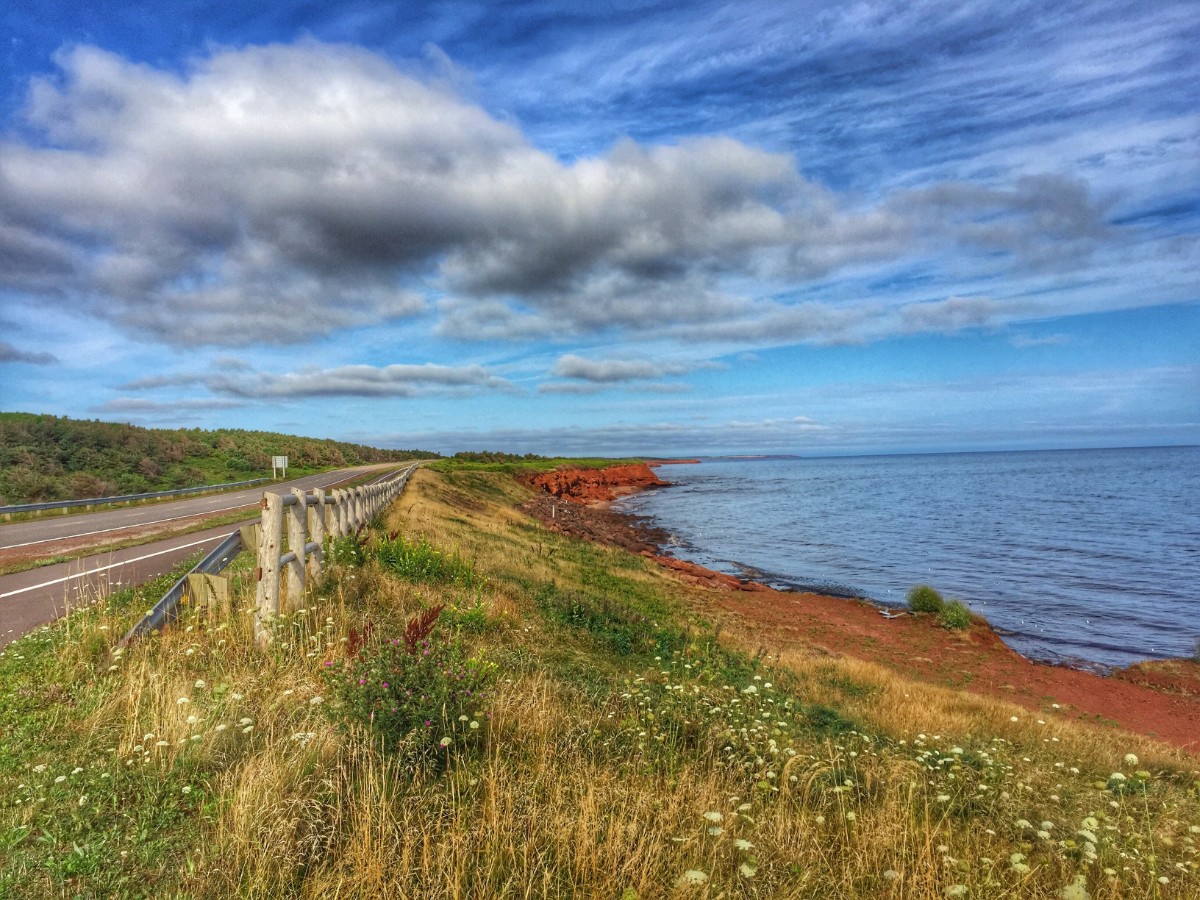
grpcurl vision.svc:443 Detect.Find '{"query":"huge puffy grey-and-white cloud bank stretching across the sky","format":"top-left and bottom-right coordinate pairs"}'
top-left (0, 42), bottom-right (1104, 350)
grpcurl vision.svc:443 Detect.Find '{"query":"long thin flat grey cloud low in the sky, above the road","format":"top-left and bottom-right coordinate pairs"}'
top-left (122, 362), bottom-right (515, 401)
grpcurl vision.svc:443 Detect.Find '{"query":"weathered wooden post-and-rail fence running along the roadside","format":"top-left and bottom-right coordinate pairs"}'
top-left (254, 464), bottom-right (416, 643)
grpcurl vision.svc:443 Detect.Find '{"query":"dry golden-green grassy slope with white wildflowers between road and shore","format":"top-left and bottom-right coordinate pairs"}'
top-left (0, 463), bottom-right (1200, 900)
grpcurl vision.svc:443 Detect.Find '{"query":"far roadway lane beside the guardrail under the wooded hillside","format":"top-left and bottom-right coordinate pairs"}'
top-left (0, 466), bottom-right (395, 549)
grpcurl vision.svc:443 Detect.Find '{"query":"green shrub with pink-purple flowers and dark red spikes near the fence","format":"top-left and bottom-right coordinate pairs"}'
top-left (325, 606), bottom-right (496, 755)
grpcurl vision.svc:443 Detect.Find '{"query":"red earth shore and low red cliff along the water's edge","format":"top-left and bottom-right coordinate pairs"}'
top-left (523, 466), bottom-right (1200, 752)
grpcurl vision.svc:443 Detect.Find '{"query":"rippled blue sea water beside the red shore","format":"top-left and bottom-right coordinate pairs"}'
top-left (620, 448), bottom-right (1200, 666)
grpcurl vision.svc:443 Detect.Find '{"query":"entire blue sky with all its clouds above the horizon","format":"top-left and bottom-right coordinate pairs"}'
top-left (0, 0), bottom-right (1200, 455)
